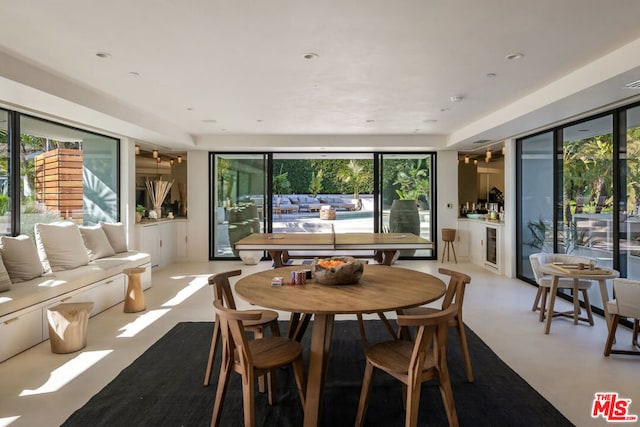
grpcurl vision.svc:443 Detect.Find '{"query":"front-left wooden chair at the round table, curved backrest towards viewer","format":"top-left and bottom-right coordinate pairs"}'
top-left (211, 300), bottom-right (306, 427)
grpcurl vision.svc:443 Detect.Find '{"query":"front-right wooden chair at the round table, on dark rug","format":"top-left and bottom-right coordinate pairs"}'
top-left (355, 304), bottom-right (458, 427)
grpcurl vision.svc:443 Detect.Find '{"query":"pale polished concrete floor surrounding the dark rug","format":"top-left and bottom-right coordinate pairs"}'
top-left (0, 261), bottom-right (640, 426)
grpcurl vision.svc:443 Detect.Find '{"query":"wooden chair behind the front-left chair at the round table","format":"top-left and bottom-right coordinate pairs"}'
top-left (204, 270), bottom-right (280, 392)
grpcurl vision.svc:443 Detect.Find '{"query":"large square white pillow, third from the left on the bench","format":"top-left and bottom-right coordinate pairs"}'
top-left (35, 221), bottom-right (89, 271)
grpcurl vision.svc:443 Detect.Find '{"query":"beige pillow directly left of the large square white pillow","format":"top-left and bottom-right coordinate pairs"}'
top-left (0, 235), bottom-right (44, 283)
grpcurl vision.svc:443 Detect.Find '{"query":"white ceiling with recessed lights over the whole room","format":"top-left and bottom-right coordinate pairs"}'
top-left (0, 0), bottom-right (640, 151)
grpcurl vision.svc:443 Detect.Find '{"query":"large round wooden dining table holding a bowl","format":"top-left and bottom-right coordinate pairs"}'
top-left (234, 265), bottom-right (446, 426)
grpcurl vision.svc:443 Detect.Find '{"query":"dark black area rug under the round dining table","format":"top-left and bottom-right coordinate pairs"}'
top-left (63, 321), bottom-right (572, 427)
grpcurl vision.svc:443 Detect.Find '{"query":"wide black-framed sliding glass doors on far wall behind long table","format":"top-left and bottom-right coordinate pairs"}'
top-left (210, 153), bottom-right (435, 259)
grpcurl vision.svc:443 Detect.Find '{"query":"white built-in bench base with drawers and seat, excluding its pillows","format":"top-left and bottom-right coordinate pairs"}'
top-left (0, 222), bottom-right (151, 361)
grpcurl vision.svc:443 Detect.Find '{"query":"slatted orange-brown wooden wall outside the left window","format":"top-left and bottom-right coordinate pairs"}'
top-left (35, 148), bottom-right (82, 224)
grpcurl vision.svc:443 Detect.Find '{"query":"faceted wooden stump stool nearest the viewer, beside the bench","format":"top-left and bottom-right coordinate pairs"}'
top-left (47, 302), bottom-right (93, 354)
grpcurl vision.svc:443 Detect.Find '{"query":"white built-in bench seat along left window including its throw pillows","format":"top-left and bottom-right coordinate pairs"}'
top-left (0, 222), bottom-right (151, 361)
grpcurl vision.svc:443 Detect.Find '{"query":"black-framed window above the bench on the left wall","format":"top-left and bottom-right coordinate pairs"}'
top-left (0, 110), bottom-right (119, 236)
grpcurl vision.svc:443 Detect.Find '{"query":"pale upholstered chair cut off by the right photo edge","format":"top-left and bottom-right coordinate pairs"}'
top-left (604, 279), bottom-right (640, 357)
